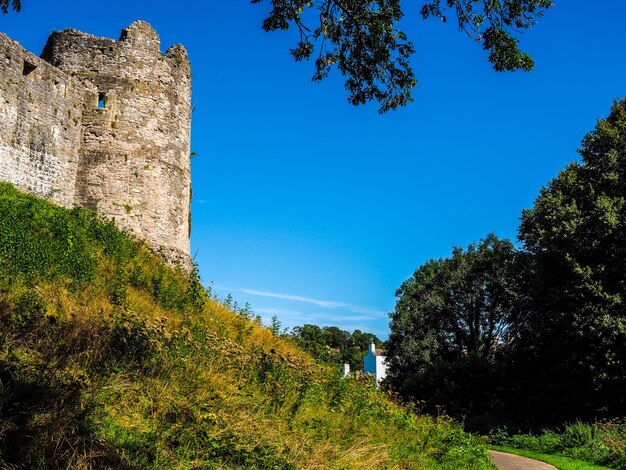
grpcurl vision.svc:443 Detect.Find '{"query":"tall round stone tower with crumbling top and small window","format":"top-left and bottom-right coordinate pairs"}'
top-left (41, 21), bottom-right (191, 264)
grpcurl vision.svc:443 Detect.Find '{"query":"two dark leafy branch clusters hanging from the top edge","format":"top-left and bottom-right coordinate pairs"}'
top-left (251, 0), bottom-right (553, 112)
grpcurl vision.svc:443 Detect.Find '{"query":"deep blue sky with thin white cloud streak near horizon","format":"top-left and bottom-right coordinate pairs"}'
top-left (0, 0), bottom-right (626, 338)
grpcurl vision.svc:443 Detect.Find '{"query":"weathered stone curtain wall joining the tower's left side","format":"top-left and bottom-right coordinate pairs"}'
top-left (0, 33), bottom-right (97, 206)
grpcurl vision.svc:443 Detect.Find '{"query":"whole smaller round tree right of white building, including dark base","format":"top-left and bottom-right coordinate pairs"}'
top-left (387, 235), bottom-right (515, 428)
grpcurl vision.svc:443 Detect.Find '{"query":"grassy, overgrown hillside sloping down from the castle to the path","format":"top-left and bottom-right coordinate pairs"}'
top-left (0, 184), bottom-right (492, 469)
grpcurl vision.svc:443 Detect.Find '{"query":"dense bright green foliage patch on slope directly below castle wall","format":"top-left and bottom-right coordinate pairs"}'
top-left (0, 183), bottom-right (137, 289)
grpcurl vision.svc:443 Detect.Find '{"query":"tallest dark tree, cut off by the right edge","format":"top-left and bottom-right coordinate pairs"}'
top-left (515, 100), bottom-right (626, 421)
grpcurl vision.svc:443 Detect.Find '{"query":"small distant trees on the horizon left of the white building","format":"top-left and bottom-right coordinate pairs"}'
top-left (284, 324), bottom-right (381, 371)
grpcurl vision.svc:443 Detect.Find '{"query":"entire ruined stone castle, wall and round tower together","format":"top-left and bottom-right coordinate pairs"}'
top-left (0, 21), bottom-right (191, 268)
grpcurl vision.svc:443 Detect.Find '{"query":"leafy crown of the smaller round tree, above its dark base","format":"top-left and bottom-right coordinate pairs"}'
top-left (389, 234), bottom-right (514, 375)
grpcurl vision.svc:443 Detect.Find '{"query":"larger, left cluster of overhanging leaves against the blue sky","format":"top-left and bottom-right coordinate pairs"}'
top-left (251, 0), bottom-right (417, 112)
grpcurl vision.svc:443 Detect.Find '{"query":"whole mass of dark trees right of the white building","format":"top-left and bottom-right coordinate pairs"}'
top-left (387, 100), bottom-right (626, 430)
